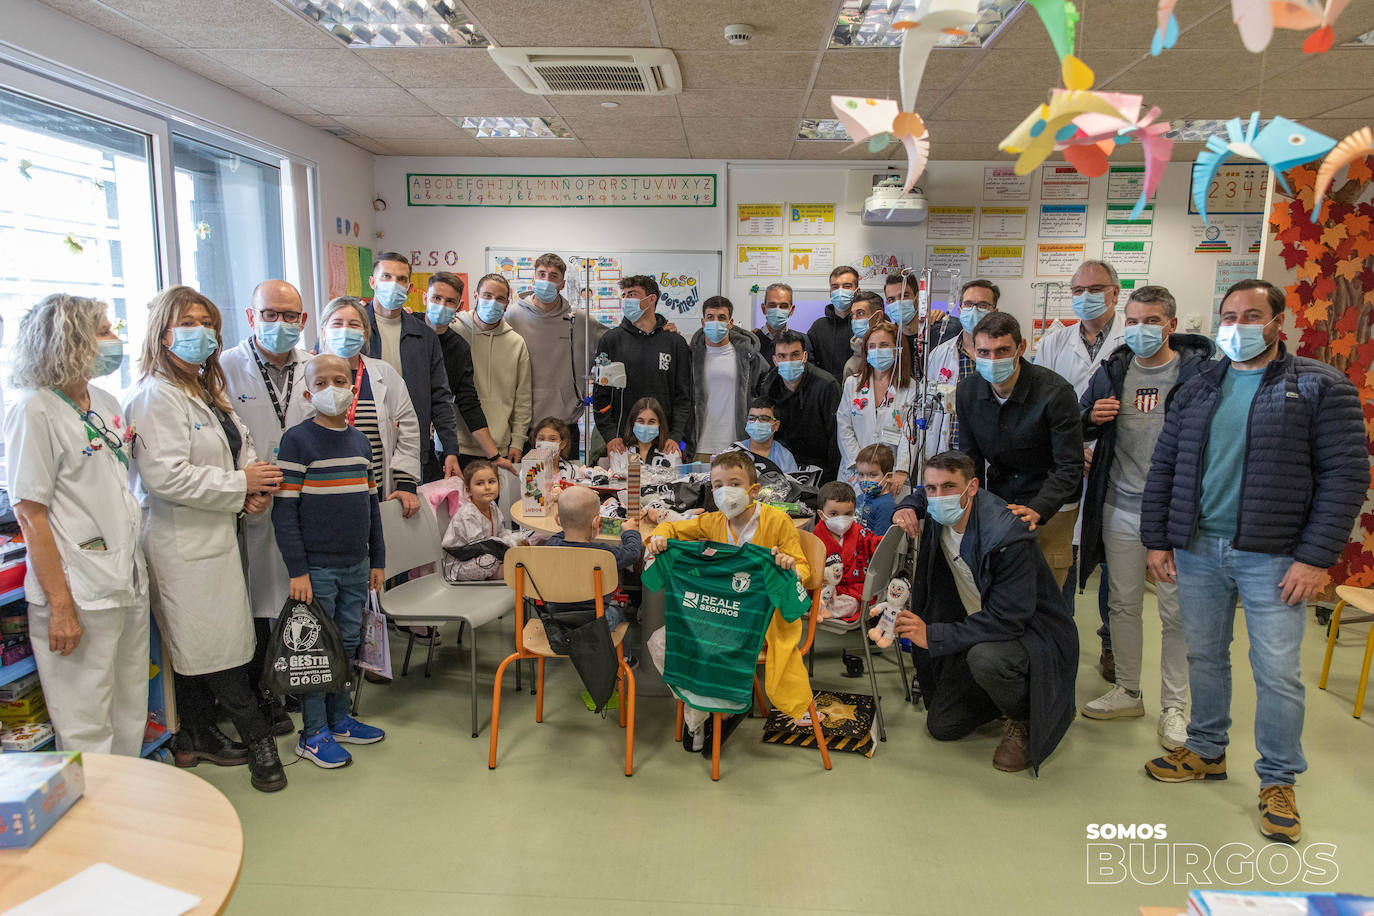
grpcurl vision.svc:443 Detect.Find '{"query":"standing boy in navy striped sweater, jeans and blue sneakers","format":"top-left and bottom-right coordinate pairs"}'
top-left (272, 354), bottom-right (386, 769)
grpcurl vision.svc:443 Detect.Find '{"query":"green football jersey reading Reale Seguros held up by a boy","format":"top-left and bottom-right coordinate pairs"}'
top-left (642, 541), bottom-right (811, 713)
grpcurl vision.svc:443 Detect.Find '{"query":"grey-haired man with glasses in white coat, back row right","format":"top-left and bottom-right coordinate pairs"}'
top-left (1032, 261), bottom-right (1125, 683)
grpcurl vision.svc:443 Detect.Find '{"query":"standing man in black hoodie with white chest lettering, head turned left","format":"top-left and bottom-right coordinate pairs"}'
top-left (592, 276), bottom-right (695, 455)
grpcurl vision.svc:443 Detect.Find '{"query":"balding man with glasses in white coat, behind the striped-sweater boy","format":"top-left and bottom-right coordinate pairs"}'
top-left (220, 280), bottom-right (312, 735)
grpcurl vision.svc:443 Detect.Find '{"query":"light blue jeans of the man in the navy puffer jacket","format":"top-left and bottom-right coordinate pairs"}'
top-left (1173, 537), bottom-right (1307, 788)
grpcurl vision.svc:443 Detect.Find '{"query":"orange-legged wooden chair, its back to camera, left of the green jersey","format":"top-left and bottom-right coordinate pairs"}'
top-left (486, 547), bottom-right (635, 776)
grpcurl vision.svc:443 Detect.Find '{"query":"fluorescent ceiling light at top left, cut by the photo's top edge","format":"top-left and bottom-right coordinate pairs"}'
top-left (278, 0), bottom-right (491, 48)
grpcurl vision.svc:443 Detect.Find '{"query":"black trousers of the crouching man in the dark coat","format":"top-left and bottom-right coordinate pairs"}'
top-left (926, 640), bottom-right (1031, 742)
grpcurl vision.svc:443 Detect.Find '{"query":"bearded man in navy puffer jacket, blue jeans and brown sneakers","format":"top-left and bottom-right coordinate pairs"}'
top-left (1140, 280), bottom-right (1370, 843)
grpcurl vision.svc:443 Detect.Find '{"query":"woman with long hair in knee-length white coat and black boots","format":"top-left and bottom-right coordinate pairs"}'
top-left (124, 286), bottom-right (286, 791)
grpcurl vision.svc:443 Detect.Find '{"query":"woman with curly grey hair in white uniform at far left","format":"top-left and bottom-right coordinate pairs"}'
top-left (4, 294), bottom-right (148, 757)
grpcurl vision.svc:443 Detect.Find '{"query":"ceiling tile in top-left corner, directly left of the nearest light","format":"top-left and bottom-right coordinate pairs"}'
top-left (100, 0), bottom-right (344, 48)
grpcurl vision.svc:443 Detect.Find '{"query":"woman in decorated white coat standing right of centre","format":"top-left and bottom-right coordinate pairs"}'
top-left (835, 319), bottom-right (919, 493)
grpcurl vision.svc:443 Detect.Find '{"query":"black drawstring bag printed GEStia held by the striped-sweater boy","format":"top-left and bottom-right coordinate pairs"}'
top-left (261, 599), bottom-right (353, 699)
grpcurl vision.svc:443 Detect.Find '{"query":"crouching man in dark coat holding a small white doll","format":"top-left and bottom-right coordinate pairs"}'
top-left (892, 452), bottom-right (1079, 773)
